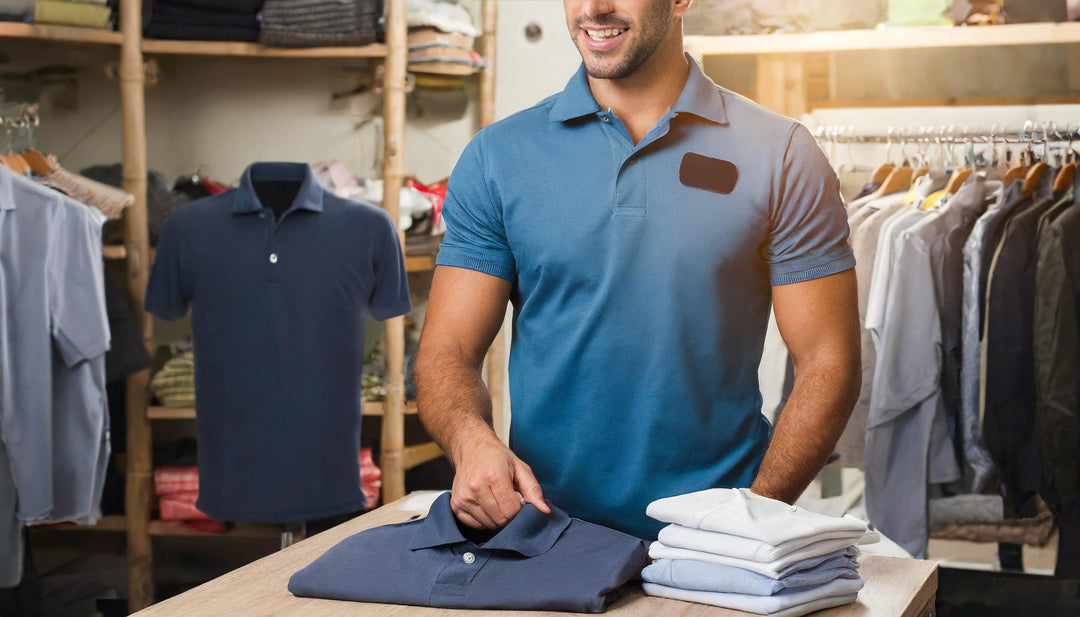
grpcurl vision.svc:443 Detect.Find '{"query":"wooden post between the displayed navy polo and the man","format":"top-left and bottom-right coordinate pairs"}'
top-left (379, 0), bottom-right (407, 504)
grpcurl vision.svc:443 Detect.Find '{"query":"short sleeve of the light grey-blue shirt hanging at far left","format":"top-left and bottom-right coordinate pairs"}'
top-left (49, 202), bottom-right (109, 366)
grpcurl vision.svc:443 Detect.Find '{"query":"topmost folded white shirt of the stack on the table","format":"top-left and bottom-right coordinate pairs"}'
top-left (645, 488), bottom-right (867, 547)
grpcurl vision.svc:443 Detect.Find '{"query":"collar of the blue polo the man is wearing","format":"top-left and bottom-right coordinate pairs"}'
top-left (548, 54), bottom-right (728, 124)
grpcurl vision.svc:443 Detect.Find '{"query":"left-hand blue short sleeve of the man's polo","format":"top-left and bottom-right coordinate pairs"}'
top-left (436, 133), bottom-right (516, 281)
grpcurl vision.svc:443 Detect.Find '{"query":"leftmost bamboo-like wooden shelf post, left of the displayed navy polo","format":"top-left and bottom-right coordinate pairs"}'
top-left (120, 0), bottom-right (153, 612)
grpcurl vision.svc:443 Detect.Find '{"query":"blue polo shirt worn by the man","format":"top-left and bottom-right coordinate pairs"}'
top-left (437, 56), bottom-right (854, 538)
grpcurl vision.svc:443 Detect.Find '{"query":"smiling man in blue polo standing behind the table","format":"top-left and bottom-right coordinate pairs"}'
top-left (416, 0), bottom-right (860, 538)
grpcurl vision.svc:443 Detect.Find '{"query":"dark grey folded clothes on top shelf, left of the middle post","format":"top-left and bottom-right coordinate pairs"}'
top-left (259, 0), bottom-right (382, 48)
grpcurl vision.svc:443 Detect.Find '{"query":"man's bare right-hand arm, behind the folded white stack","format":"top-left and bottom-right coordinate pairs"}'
top-left (751, 270), bottom-right (862, 504)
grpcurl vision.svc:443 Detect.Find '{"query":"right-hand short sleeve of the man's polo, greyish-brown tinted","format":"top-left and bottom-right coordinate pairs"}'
top-left (765, 123), bottom-right (855, 285)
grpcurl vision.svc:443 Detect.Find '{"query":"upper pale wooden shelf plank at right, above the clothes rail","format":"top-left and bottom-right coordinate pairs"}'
top-left (685, 23), bottom-right (1080, 57)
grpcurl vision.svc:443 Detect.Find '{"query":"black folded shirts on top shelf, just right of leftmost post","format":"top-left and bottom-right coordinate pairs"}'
top-left (143, 0), bottom-right (262, 41)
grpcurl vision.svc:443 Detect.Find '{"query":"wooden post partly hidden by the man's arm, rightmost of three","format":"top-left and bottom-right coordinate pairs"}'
top-left (480, 0), bottom-right (510, 445)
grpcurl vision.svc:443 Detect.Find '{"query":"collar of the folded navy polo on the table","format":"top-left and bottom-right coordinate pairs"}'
top-left (408, 493), bottom-right (570, 556)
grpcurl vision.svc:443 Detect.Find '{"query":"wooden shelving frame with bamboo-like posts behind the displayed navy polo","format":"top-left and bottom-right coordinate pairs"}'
top-left (0, 0), bottom-right (496, 612)
